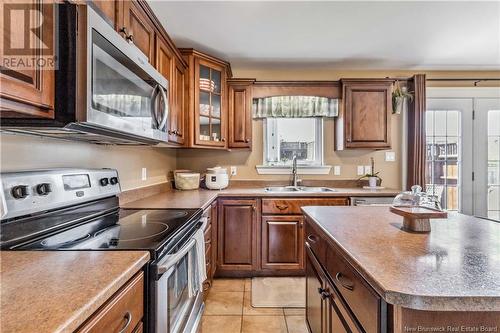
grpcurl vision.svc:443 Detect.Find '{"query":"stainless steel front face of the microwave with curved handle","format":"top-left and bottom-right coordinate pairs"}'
top-left (85, 6), bottom-right (169, 142)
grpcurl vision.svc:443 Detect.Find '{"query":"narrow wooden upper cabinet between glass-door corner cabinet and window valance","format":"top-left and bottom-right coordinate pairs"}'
top-left (227, 79), bottom-right (255, 148)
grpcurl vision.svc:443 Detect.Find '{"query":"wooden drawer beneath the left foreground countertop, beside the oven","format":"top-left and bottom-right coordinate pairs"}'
top-left (78, 272), bottom-right (144, 333)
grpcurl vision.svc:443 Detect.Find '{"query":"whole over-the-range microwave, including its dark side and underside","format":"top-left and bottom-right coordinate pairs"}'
top-left (2, 3), bottom-right (169, 145)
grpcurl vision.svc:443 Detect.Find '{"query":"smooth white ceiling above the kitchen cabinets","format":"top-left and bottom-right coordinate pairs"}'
top-left (149, 0), bottom-right (500, 70)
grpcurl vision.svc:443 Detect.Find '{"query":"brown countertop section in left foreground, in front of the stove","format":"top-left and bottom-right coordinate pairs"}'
top-left (0, 251), bottom-right (149, 333)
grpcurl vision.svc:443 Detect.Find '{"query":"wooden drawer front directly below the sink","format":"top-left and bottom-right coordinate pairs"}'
top-left (262, 198), bottom-right (349, 215)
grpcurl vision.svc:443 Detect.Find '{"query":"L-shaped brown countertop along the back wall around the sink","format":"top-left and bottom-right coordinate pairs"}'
top-left (122, 187), bottom-right (400, 209)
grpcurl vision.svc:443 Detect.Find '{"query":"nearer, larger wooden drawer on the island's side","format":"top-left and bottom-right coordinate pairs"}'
top-left (326, 245), bottom-right (381, 333)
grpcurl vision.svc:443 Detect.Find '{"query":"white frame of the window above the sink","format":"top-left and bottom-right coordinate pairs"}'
top-left (262, 117), bottom-right (325, 168)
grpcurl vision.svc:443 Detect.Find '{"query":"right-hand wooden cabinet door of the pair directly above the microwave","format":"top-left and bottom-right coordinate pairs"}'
top-left (118, 1), bottom-right (155, 63)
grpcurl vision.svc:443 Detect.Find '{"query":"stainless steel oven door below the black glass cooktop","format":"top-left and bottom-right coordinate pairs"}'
top-left (156, 239), bottom-right (203, 333)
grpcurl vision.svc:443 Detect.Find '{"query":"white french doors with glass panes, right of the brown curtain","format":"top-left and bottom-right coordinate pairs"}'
top-left (425, 88), bottom-right (500, 220)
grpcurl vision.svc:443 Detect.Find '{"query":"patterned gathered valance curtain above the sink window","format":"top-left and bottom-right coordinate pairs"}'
top-left (253, 96), bottom-right (339, 118)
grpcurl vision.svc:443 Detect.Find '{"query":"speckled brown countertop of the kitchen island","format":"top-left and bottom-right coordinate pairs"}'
top-left (303, 207), bottom-right (500, 311)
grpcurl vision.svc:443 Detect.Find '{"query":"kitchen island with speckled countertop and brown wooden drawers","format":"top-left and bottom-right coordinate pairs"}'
top-left (303, 207), bottom-right (500, 333)
